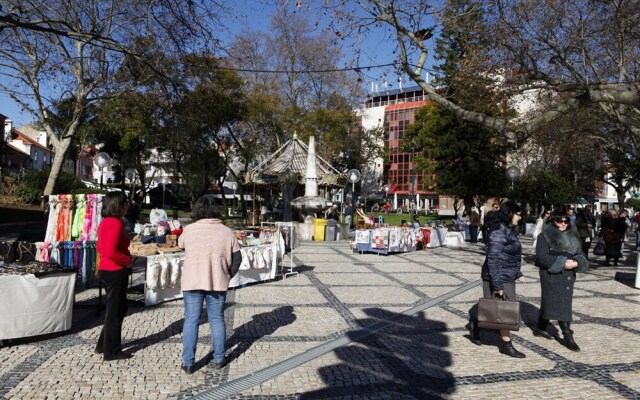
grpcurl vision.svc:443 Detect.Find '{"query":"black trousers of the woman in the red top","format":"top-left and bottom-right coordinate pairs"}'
top-left (96, 268), bottom-right (131, 360)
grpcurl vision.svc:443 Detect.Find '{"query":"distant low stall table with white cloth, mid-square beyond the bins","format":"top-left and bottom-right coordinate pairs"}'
top-left (354, 227), bottom-right (423, 255)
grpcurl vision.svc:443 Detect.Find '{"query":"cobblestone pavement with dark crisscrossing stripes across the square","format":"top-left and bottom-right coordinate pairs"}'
top-left (0, 238), bottom-right (640, 399)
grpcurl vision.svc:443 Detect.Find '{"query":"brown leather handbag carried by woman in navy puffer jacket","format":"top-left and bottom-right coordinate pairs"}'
top-left (478, 295), bottom-right (520, 331)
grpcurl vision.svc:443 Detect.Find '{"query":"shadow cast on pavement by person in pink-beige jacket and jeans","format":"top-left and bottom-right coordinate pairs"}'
top-left (196, 306), bottom-right (296, 365)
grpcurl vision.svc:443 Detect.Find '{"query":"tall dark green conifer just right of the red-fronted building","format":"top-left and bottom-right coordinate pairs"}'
top-left (404, 0), bottom-right (507, 211)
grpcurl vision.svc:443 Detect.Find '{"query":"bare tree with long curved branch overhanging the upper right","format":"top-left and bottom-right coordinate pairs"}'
top-left (320, 0), bottom-right (640, 139)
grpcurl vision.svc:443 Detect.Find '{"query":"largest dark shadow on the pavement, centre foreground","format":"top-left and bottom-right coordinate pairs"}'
top-left (300, 308), bottom-right (455, 399)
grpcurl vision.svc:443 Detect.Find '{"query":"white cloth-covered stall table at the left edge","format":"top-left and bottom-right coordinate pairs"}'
top-left (0, 261), bottom-right (78, 340)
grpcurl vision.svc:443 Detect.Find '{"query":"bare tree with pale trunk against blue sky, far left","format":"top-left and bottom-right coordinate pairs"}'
top-left (0, 0), bottom-right (221, 195)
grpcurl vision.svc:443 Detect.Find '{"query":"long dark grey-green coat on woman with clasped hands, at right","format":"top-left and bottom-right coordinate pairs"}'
top-left (536, 223), bottom-right (589, 322)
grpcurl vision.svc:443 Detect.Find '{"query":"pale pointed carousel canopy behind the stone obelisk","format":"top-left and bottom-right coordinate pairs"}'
top-left (245, 133), bottom-right (345, 221)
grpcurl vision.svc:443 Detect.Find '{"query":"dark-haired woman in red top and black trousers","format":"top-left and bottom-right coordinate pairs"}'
top-left (96, 192), bottom-right (131, 361)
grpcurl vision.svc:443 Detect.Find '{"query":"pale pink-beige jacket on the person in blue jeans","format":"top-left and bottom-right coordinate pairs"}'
top-left (178, 219), bottom-right (240, 291)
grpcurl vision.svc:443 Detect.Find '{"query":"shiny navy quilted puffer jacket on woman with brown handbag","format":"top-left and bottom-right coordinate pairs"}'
top-left (482, 222), bottom-right (522, 291)
